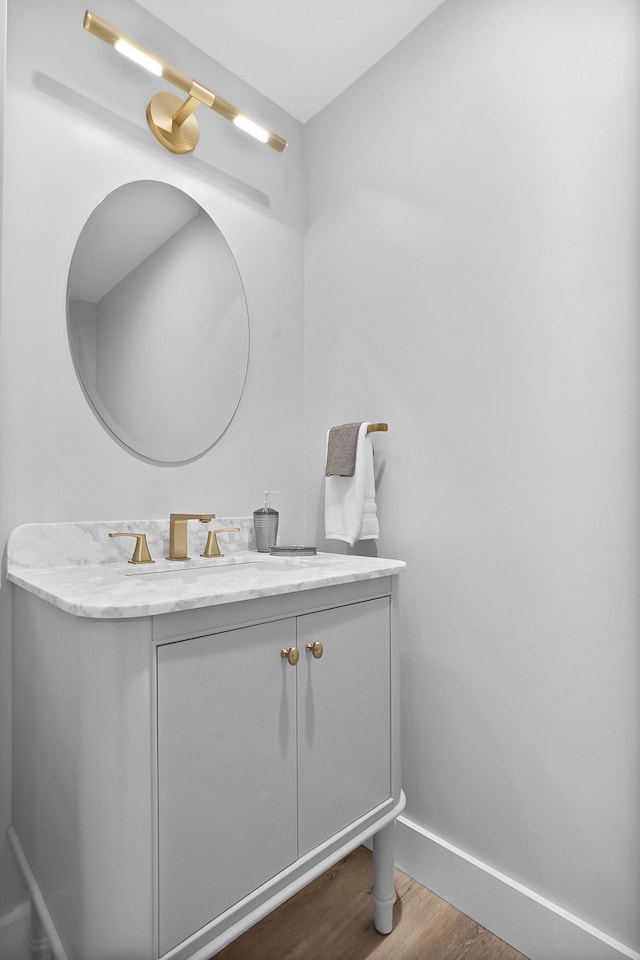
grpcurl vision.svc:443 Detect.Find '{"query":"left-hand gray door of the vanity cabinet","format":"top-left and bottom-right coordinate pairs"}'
top-left (157, 619), bottom-right (297, 954)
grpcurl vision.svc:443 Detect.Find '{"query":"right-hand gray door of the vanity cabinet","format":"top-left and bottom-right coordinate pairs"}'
top-left (297, 598), bottom-right (391, 856)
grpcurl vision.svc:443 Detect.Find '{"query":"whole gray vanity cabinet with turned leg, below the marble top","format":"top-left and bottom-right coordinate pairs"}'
top-left (9, 577), bottom-right (404, 960)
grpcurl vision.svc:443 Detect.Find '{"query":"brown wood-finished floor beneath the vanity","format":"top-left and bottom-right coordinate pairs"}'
top-left (215, 847), bottom-right (527, 960)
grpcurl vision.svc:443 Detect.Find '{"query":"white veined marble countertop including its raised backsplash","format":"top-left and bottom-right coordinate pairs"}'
top-left (7, 518), bottom-right (406, 619)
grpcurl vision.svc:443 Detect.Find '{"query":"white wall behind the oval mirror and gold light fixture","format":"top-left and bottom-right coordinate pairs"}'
top-left (0, 0), bottom-right (304, 917)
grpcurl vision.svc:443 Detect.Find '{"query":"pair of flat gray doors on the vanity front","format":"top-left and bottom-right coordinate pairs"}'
top-left (157, 597), bottom-right (391, 954)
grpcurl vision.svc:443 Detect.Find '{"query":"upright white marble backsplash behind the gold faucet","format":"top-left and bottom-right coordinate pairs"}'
top-left (7, 517), bottom-right (256, 569)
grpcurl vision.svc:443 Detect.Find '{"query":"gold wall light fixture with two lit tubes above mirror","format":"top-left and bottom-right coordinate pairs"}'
top-left (83, 10), bottom-right (287, 153)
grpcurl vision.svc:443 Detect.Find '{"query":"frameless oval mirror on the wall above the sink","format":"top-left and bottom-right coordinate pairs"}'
top-left (67, 180), bottom-right (249, 464)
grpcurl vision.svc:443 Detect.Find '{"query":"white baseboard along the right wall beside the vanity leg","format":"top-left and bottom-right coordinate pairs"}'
top-left (395, 816), bottom-right (640, 960)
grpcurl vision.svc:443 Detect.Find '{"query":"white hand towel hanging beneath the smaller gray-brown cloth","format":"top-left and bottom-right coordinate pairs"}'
top-left (324, 423), bottom-right (379, 545)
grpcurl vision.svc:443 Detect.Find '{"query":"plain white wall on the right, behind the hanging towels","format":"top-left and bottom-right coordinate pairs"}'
top-left (305, 0), bottom-right (640, 960)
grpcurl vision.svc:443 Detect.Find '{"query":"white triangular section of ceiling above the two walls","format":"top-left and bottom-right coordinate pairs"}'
top-left (134, 0), bottom-right (444, 123)
